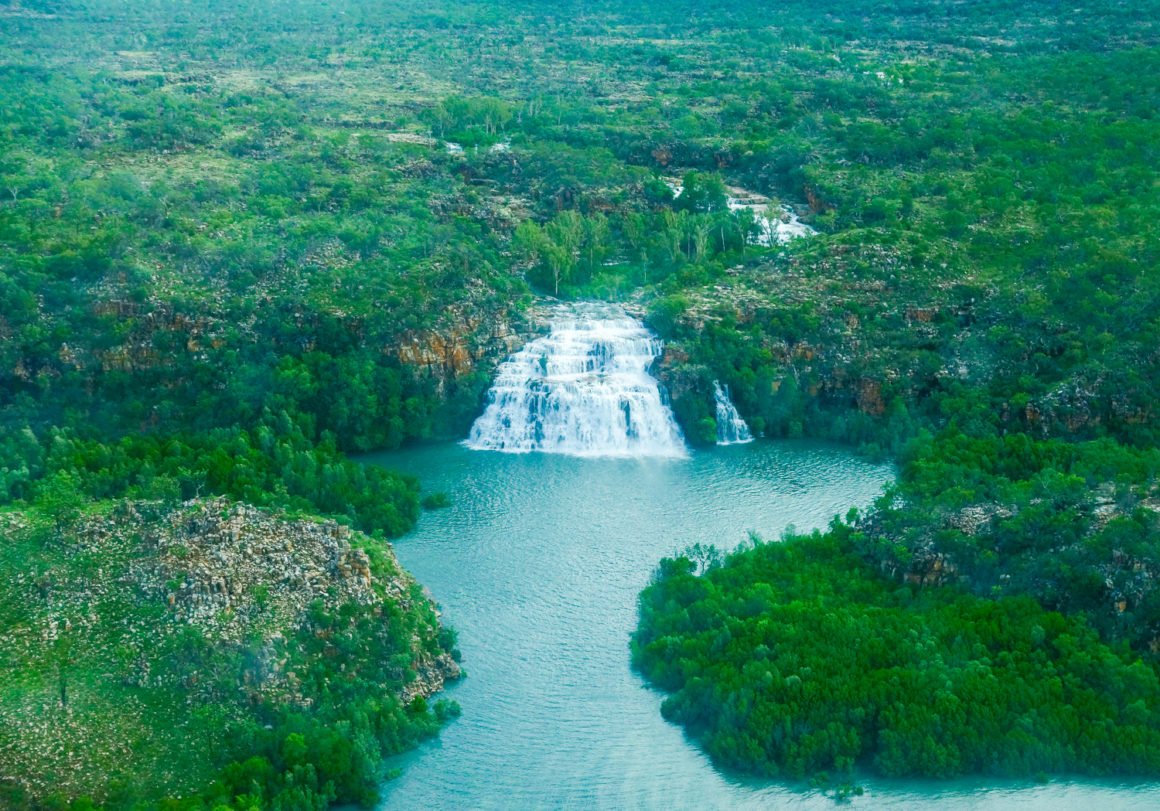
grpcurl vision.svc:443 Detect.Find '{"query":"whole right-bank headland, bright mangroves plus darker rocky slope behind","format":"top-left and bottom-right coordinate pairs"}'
top-left (632, 429), bottom-right (1160, 779)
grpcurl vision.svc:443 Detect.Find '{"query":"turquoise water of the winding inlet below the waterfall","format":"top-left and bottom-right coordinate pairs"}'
top-left (368, 441), bottom-right (1160, 811)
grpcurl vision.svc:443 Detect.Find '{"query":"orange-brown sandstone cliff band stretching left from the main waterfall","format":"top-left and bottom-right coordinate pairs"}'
top-left (0, 272), bottom-right (534, 429)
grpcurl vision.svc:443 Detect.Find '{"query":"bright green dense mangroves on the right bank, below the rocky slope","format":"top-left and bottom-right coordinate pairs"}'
top-left (632, 526), bottom-right (1160, 779)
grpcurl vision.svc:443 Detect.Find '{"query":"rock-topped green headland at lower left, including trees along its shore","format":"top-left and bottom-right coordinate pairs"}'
top-left (0, 500), bottom-right (458, 811)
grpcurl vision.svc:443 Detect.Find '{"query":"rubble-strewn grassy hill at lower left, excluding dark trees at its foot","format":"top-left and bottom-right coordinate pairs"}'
top-left (0, 499), bottom-right (459, 798)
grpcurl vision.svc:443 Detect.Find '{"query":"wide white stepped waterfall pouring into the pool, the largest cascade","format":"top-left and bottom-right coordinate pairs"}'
top-left (465, 305), bottom-right (686, 456)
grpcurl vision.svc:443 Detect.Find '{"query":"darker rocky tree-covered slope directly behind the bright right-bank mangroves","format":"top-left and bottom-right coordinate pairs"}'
top-left (858, 430), bottom-right (1160, 649)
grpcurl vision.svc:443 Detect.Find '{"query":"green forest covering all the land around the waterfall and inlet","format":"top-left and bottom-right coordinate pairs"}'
top-left (0, 0), bottom-right (1160, 811)
